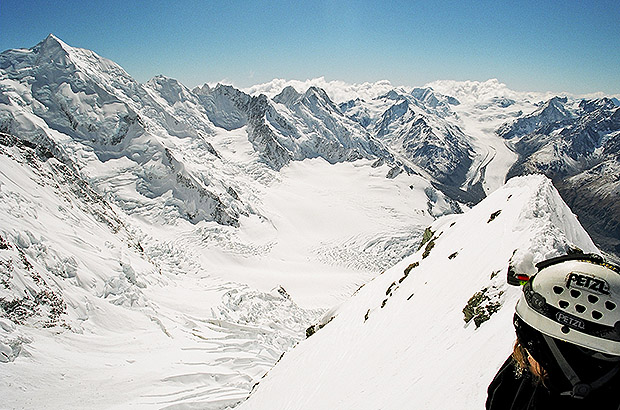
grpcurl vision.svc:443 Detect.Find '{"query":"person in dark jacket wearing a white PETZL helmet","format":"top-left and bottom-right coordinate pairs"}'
top-left (486, 254), bottom-right (620, 410)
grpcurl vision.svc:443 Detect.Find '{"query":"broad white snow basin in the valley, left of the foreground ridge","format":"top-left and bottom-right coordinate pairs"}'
top-left (0, 126), bottom-right (449, 409)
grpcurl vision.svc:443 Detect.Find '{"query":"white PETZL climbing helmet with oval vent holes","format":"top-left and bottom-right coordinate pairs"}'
top-left (516, 254), bottom-right (620, 356)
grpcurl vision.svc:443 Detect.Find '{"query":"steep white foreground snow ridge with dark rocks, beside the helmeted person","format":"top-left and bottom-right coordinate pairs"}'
top-left (240, 176), bottom-right (596, 410)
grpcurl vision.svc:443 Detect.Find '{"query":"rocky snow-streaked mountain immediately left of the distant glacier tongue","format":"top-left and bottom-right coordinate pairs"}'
top-left (340, 88), bottom-right (484, 202)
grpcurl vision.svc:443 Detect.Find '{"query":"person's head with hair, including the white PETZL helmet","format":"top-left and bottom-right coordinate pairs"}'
top-left (514, 254), bottom-right (620, 397)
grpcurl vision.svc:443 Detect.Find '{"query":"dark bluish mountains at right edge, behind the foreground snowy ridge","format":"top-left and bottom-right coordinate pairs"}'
top-left (498, 98), bottom-right (620, 254)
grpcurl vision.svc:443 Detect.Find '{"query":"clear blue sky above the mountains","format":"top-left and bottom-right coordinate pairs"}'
top-left (0, 0), bottom-right (620, 94)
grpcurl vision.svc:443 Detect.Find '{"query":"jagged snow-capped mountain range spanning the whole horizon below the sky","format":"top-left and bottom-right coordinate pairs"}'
top-left (0, 35), bottom-right (620, 252)
